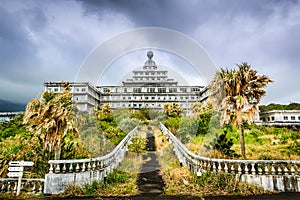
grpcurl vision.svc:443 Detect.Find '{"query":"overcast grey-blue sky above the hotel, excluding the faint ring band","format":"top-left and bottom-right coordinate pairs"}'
top-left (0, 0), bottom-right (300, 104)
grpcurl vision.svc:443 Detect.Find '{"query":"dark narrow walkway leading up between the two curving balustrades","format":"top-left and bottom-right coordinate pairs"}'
top-left (137, 126), bottom-right (165, 195)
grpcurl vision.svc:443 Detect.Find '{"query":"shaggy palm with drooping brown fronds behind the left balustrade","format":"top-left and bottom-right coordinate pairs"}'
top-left (23, 82), bottom-right (77, 160)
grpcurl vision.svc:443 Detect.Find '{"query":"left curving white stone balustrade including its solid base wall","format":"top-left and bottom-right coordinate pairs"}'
top-left (44, 127), bottom-right (138, 194)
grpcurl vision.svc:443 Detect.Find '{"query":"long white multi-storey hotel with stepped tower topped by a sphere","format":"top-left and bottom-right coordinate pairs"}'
top-left (44, 51), bottom-right (205, 111)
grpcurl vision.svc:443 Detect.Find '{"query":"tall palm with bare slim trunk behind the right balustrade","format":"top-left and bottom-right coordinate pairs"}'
top-left (210, 63), bottom-right (273, 159)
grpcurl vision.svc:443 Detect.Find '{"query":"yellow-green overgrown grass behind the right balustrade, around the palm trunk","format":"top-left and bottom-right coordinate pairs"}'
top-left (186, 125), bottom-right (300, 160)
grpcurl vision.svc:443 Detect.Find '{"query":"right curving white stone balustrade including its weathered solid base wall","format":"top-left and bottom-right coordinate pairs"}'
top-left (160, 123), bottom-right (300, 191)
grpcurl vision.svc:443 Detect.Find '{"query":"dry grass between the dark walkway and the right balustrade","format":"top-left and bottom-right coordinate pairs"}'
top-left (155, 128), bottom-right (267, 197)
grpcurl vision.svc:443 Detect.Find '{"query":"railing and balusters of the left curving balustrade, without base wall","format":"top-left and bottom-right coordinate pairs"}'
top-left (48, 127), bottom-right (138, 174)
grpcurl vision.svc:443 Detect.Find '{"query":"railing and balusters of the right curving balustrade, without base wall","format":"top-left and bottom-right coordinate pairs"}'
top-left (160, 123), bottom-right (300, 176)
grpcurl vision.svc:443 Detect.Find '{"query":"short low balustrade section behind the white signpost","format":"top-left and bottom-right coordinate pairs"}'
top-left (0, 178), bottom-right (45, 195)
